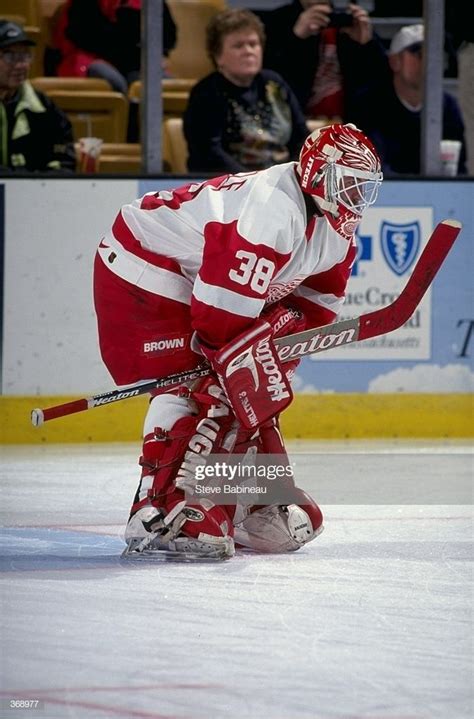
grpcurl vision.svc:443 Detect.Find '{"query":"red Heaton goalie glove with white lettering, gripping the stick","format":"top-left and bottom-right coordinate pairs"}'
top-left (200, 307), bottom-right (304, 429)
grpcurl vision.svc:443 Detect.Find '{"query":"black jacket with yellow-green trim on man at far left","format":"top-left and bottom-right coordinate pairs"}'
top-left (0, 82), bottom-right (76, 173)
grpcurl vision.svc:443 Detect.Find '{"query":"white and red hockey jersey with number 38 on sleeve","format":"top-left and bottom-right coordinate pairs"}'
top-left (99, 162), bottom-right (357, 347)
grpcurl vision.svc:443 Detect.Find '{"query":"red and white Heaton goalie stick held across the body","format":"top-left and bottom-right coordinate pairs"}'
top-left (31, 220), bottom-right (462, 427)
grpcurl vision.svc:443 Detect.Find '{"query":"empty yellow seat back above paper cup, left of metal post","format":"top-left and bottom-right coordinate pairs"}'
top-left (48, 90), bottom-right (128, 142)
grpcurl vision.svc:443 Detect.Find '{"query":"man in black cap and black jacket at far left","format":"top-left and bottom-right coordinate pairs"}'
top-left (0, 20), bottom-right (76, 173)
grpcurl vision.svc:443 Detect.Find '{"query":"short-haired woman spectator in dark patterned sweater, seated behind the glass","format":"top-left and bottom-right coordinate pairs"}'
top-left (184, 9), bottom-right (308, 172)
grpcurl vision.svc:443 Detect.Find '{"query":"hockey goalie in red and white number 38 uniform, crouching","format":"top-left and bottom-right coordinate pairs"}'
top-left (94, 124), bottom-right (382, 559)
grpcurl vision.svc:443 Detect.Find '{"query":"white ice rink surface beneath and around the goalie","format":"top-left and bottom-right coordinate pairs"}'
top-left (0, 443), bottom-right (474, 719)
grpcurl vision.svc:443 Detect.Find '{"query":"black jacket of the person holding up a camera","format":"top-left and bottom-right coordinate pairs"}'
top-left (258, 0), bottom-right (390, 122)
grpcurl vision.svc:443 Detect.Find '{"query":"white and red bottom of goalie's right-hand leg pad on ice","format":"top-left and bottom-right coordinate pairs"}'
top-left (234, 502), bottom-right (323, 553)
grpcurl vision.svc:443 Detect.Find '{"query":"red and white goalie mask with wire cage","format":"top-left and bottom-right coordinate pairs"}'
top-left (297, 124), bottom-right (383, 217)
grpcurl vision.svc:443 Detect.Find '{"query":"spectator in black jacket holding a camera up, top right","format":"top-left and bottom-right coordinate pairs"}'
top-left (259, 0), bottom-right (387, 121)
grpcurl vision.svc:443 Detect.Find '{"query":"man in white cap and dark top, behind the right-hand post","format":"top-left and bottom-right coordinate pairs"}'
top-left (354, 24), bottom-right (466, 175)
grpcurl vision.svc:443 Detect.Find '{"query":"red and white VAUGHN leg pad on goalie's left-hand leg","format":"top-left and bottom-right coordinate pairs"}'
top-left (125, 380), bottom-right (235, 556)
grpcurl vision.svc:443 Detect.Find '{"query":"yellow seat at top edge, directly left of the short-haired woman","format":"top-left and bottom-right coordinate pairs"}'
top-left (168, 0), bottom-right (227, 79)
